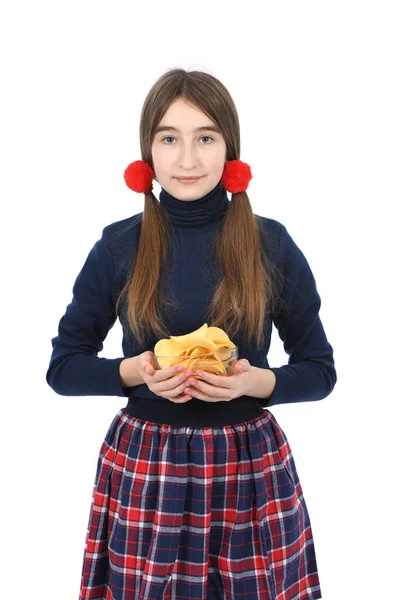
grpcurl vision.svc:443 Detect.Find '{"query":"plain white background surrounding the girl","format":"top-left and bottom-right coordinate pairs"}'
top-left (0, 0), bottom-right (400, 600)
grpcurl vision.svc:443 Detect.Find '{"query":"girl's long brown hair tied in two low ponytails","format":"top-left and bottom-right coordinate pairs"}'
top-left (116, 69), bottom-right (281, 349)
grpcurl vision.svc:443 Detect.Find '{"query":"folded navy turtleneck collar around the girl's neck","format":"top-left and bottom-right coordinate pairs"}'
top-left (160, 181), bottom-right (229, 227)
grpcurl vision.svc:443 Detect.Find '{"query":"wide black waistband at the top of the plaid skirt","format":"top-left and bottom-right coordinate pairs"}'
top-left (124, 396), bottom-right (265, 427)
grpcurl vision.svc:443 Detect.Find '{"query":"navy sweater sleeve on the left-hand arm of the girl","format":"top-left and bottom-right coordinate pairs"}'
top-left (46, 229), bottom-right (133, 397)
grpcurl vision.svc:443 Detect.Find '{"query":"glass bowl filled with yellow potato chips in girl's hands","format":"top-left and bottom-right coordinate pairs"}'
top-left (154, 323), bottom-right (239, 379)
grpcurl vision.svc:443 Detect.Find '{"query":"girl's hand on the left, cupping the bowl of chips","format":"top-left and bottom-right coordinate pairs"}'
top-left (137, 350), bottom-right (193, 403)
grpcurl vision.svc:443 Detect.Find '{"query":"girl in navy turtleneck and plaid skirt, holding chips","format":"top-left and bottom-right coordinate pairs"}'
top-left (46, 69), bottom-right (336, 600)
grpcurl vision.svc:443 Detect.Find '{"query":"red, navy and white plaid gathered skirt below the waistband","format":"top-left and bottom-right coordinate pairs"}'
top-left (79, 409), bottom-right (322, 600)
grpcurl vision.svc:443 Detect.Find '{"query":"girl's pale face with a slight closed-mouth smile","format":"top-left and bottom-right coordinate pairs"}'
top-left (151, 98), bottom-right (226, 201)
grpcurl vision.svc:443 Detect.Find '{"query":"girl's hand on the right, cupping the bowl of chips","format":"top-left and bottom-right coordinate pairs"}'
top-left (184, 358), bottom-right (252, 402)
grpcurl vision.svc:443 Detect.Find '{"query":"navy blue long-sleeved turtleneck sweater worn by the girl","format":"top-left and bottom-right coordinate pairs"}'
top-left (46, 182), bottom-right (336, 425)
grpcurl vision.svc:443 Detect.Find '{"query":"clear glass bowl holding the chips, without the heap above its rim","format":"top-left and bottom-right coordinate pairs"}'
top-left (154, 346), bottom-right (239, 379)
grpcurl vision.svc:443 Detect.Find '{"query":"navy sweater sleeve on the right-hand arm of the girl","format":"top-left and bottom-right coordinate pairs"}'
top-left (265, 225), bottom-right (337, 407)
